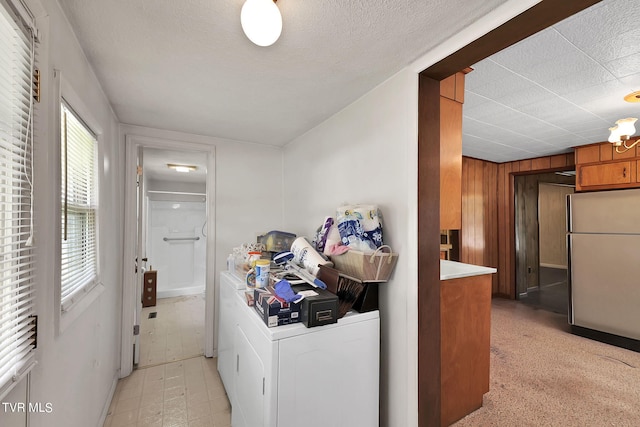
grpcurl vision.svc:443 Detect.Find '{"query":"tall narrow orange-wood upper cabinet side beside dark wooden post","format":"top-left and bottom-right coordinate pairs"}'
top-left (440, 68), bottom-right (471, 230)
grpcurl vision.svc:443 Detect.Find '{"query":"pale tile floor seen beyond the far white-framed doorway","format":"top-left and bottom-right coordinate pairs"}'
top-left (138, 294), bottom-right (204, 367)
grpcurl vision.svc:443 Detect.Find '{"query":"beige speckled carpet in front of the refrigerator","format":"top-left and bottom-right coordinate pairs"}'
top-left (455, 300), bottom-right (640, 427)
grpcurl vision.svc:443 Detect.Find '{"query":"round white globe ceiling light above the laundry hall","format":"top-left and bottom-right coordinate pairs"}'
top-left (240, 0), bottom-right (282, 47)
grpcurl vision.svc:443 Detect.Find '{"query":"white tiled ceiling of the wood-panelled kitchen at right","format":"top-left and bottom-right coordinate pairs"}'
top-left (463, 0), bottom-right (640, 162)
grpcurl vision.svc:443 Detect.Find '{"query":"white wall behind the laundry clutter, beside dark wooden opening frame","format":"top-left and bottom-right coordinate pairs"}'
top-left (284, 70), bottom-right (418, 427)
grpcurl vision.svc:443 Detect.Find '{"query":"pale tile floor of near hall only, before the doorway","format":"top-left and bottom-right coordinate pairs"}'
top-left (104, 356), bottom-right (231, 427)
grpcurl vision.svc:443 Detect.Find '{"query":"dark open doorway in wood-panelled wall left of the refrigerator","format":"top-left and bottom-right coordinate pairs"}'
top-left (514, 172), bottom-right (575, 315)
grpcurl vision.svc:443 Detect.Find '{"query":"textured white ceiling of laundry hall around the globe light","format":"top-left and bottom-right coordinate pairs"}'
top-left (59, 0), bottom-right (506, 145)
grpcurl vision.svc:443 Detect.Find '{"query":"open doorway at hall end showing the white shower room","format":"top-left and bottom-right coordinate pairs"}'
top-left (121, 135), bottom-right (215, 377)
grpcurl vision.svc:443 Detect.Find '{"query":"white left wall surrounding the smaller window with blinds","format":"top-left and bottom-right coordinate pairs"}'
top-left (0, 0), bottom-right (122, 427)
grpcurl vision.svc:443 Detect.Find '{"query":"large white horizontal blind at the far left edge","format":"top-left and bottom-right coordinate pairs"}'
top-left (0, 3), bottom-right (35, 399)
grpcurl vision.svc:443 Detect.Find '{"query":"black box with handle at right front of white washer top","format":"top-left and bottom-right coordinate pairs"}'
top-left (291, 283), bottom-right (338, 328)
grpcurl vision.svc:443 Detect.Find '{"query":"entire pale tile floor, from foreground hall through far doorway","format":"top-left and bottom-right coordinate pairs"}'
top-left (104, 295), bottom-right (231, 427)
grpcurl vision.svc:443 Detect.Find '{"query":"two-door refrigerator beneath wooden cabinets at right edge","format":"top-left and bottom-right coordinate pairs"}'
top-left (567, 189), bottom-right (640, 344)
